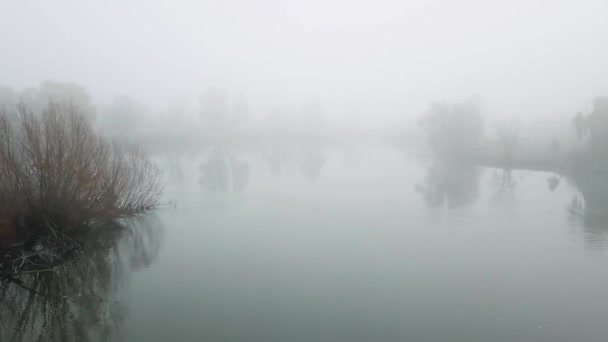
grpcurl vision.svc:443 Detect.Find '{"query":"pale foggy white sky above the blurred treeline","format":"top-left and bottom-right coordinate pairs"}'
top-left (0, 0), bottom-right (608, 122)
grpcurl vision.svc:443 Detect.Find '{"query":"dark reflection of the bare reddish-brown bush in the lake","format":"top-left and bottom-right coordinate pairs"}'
top-left (0, 217), bottom-right (162, 342)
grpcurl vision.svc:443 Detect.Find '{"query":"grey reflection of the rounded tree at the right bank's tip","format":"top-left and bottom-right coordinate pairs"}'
top-left (416, 160), bottom-right (481, 209)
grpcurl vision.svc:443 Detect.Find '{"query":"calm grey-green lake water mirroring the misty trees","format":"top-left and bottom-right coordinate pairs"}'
top-left (0, 147), bottom-right (608, 342)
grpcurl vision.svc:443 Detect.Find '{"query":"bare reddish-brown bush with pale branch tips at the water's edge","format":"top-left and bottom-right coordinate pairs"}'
top-left (0, 101), bottom-right (161, 248)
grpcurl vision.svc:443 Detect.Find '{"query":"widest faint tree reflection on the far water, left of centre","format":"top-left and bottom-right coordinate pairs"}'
top-left (199, 146), bottom-right (249, 192)
